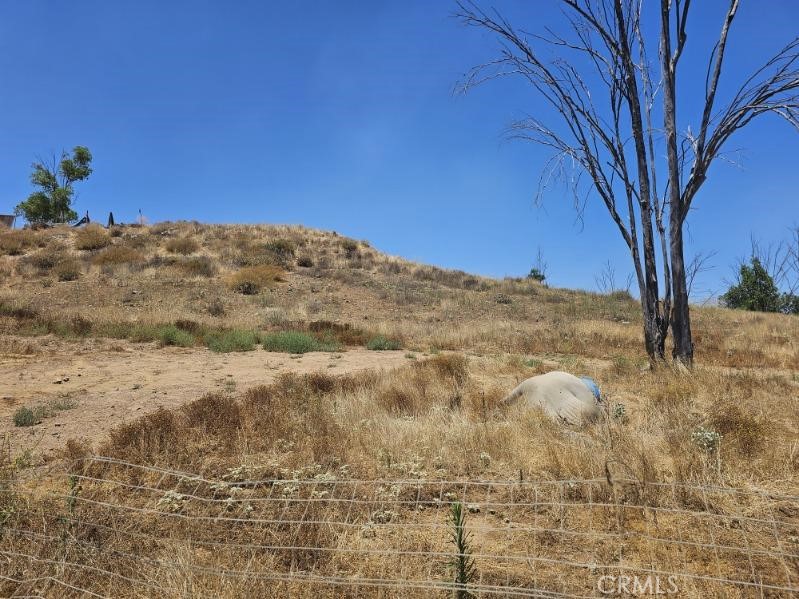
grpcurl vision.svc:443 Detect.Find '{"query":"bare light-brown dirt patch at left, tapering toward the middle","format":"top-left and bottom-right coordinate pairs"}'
top-left (0, 339), bottom-right (408, 456)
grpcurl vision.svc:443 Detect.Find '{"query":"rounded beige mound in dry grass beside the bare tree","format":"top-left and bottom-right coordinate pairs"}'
top-left (501, 371), bottom-right (601, 425)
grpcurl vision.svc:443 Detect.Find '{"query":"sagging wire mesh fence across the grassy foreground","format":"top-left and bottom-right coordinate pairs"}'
top-left (0, 457), bottom-right (799, 599)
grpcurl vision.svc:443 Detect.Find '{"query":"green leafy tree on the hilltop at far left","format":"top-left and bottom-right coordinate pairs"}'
top-left (15, 146), bottom-right (92, 224)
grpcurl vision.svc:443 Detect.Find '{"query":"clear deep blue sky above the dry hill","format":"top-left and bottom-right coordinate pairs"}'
top-left (0, 0), bottom-right (799, 298)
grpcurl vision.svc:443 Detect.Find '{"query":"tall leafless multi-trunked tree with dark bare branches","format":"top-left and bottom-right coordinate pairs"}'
top-left (456, 0), bottom-right (799, 365)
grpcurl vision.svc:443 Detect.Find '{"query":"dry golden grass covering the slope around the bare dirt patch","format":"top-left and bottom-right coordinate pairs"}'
top-left (0, 223), bottom-right (799, 598)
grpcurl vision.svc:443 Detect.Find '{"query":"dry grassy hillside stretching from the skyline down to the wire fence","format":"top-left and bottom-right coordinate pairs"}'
top-left (0, 223), bottom-right (799, 597)
